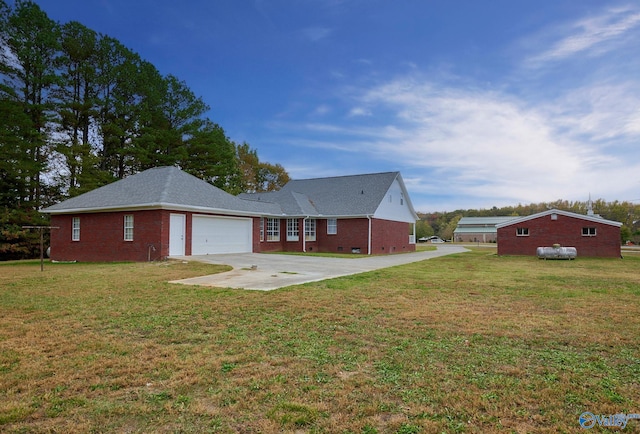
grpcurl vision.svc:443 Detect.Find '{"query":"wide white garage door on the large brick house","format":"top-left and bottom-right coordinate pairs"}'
top-left (191, 215), bottom-right (253, 255)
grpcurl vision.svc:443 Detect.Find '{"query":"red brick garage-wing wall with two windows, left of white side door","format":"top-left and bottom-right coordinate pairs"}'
top-left (51, 210), bottom-right (169, 262)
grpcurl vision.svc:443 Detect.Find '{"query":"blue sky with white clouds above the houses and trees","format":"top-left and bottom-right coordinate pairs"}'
top-left (28, 0), bottom-right (640, 212)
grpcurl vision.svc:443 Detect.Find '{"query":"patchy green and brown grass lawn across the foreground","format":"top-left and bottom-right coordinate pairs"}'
top-left (0, 248), bottom-right (640, 433)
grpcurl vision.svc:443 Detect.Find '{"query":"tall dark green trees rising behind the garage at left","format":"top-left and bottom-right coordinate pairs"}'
top-left (0, 0), bottom-right (289, 259)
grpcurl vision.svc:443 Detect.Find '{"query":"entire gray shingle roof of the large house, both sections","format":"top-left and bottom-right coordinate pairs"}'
top-left (42, 167), bottom-right (415, 217)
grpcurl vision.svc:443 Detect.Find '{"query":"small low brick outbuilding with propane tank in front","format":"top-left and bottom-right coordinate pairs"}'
top-left (496, 209), bottom-right (622, 258)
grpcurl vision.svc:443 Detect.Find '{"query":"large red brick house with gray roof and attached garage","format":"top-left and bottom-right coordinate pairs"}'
top-left (42, 167), bottom-right (417, 261)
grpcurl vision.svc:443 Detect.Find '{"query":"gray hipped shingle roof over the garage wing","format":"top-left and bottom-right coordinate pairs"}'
top-left (42, 167), bottom-right (282, 214)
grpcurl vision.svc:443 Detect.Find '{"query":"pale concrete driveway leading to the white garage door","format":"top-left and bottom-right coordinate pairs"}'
top-left (171, 244), bottom-right (467, 291)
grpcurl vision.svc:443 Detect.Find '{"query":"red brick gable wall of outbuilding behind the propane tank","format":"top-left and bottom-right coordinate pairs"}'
top-left (498, 214), bottom-right (621, 258)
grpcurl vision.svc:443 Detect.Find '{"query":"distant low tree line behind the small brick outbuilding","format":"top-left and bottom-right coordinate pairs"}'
top-left (416, 199), bottom-right (640, 244)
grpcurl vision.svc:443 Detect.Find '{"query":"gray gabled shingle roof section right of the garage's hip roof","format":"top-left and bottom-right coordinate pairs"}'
top-left (239, 172), bottom-right (400, 216)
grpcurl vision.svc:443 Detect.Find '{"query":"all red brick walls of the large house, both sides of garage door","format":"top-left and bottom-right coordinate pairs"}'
top-left (51, 210), bottom-right (418, 262)
